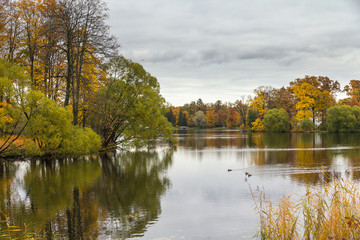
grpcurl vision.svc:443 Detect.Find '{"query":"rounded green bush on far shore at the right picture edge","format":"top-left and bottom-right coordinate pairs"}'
top-left (326, 105), bottom-right (359, 132)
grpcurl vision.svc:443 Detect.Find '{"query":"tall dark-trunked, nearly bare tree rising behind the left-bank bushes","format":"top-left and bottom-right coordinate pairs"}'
top-left (54, 0), bottom-right (118, 125)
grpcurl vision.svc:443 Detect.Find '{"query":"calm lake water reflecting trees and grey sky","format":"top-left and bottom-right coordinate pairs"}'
top-left (0, 130), bottom-right (360, 239)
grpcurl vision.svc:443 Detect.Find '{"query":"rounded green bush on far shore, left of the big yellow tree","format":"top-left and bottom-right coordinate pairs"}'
top-left (264, 108), bottom-right (290, 132)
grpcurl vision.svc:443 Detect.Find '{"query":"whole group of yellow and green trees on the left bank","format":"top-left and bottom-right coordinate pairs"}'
top-left (0, 0), bottom-right (173, 157)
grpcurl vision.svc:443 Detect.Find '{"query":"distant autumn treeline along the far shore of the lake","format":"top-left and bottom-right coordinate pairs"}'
top-left (166, 76), bottom-right (360, 132)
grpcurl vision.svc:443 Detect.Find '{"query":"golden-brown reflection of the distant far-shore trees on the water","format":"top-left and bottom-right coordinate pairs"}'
top-left (177, 130), bottom-right (360, 185)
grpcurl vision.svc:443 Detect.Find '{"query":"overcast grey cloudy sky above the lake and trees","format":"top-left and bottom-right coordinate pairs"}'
top-left (105, 0), bottom-right (360, 106)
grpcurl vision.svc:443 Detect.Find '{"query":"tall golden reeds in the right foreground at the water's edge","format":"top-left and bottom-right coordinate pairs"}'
top-left (252, 176), bottom-right (360, 240)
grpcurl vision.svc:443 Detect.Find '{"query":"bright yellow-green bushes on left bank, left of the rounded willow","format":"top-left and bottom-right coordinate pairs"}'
top-left (26, 91), bottom-right (101, 155)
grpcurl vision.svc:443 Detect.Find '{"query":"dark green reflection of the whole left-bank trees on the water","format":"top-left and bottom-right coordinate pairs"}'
top-left (0, 151), bottom-right (172, 239)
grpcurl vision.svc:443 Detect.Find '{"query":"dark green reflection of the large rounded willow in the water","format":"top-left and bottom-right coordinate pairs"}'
top-left (95, 151), bottom-right (173, 238)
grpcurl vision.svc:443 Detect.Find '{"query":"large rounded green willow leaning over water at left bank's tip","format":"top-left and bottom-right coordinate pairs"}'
top-left (89, 57), bottom-right (172, 148)
